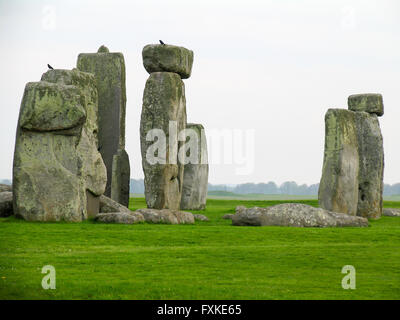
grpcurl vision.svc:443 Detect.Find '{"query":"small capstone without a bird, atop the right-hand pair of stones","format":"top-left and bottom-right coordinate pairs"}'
top-left (348, 93), bottom-right (383, 116)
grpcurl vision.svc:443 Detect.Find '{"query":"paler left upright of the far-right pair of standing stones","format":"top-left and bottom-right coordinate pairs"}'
top-left (318, 109), bottom-right (359, 215)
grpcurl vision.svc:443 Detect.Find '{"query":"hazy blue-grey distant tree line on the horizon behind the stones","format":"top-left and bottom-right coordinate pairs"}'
top-left (0, 179), bottom-right (400, 196)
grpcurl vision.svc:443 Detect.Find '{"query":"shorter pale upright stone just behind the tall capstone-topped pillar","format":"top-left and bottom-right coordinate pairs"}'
top-left (181, 123), bottom-right (208, 210)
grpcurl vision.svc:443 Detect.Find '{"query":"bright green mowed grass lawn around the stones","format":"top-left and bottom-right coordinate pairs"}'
top-left (0, 198), bottom-right (400, 299)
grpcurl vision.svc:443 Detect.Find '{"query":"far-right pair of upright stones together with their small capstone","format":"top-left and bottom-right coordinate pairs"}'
top-left (318, 94), bottom-right (384, 219)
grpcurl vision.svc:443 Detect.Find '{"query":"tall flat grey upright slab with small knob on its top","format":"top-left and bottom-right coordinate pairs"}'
top-left (77, 46), bottom-right (130, 206)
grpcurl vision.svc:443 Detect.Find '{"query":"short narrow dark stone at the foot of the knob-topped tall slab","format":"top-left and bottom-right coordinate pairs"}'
top-left (111, 149), bottom-right (131, 207)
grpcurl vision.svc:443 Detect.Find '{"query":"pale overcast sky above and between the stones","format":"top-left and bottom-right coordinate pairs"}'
top-left (0, 0), bottom-right (400, 184)
